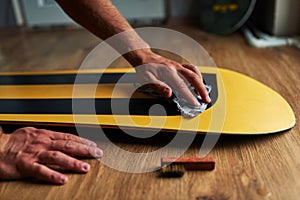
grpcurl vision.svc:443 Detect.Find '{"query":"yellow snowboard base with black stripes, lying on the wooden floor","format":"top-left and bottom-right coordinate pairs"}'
top-left (0, 67), bottom-right (295, 135)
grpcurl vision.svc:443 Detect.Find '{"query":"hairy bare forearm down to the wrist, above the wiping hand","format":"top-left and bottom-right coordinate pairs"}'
top-left (56, 0), bottom-right (153, 66)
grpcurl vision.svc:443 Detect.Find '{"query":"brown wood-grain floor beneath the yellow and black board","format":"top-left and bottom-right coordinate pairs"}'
top-left (0, 22), bottom-right (300, 200)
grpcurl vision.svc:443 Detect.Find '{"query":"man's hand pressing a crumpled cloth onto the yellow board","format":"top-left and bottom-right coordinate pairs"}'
top-left (124, 49), bottom-right (211, 106)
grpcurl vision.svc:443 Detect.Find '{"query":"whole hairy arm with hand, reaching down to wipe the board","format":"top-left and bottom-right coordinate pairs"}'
top-left (56, 0), bottom-right (211, 106)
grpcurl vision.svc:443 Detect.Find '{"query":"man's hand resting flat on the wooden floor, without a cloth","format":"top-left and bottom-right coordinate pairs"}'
top-left (0, 127), bottom-right (103, 184)
